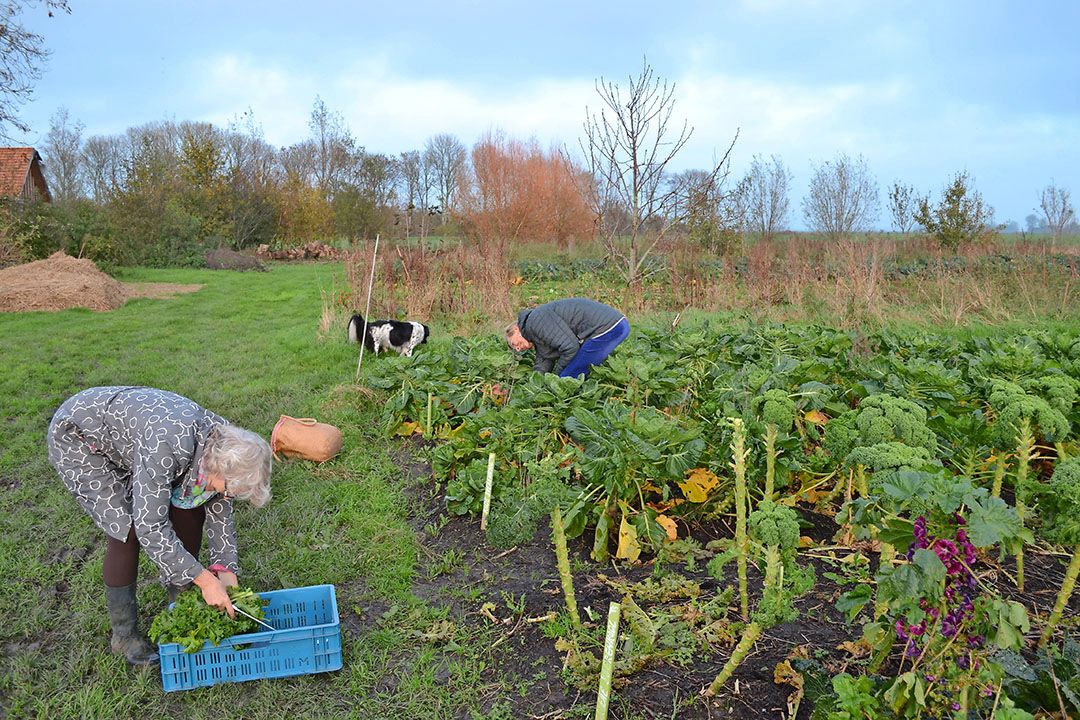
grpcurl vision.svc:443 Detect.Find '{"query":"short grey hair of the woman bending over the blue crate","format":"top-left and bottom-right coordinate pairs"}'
top-left (203, 425), bottom-right (271, 507)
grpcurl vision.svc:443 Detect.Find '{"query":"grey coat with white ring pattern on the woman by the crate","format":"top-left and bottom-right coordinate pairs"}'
top-left (48, 388), bottom-right (238, 585)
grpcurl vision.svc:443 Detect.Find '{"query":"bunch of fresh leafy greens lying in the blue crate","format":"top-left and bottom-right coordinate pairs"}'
top-left (150, 587), bottom-right (265, 652)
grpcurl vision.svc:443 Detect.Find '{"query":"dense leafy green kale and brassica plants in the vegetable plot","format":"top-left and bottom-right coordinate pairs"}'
top-left (373, 324), bottom-right (1080, 718)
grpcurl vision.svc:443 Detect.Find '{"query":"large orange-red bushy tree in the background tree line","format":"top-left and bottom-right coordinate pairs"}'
top-left (460, 131), bottom-right (595, 246)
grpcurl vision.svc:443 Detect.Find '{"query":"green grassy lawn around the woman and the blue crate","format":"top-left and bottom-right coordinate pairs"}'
top-left (0, 264), bottom-right (514, 719)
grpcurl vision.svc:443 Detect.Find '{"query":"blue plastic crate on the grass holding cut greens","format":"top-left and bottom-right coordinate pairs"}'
top-left (158, 585), bottom-right (341, 692)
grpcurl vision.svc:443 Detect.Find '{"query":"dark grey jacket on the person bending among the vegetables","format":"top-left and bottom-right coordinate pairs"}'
top-left (517, 298), bottom-right (623, 372)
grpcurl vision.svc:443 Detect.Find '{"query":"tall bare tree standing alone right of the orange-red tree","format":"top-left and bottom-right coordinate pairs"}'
top-left (581, 59), bottom-right (739, 284)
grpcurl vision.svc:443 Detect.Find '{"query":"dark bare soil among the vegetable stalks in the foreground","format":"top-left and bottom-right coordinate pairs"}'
top-left (395, 446), bottom-right (1080, 720)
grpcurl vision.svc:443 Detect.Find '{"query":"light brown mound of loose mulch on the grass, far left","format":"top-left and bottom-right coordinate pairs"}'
top-left (0, 250), bottom-right (127, 312)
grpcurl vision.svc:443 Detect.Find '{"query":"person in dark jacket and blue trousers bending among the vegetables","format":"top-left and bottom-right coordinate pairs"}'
top-left (507, 298), bottom-right (630, 378)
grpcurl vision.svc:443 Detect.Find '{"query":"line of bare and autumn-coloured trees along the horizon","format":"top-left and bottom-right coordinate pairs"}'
top-left (0, 62), bottom-right (1076, 268)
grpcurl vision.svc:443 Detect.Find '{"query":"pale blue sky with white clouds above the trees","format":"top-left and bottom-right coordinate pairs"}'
top-left (12, 0), bottom-right (1080, 229)
